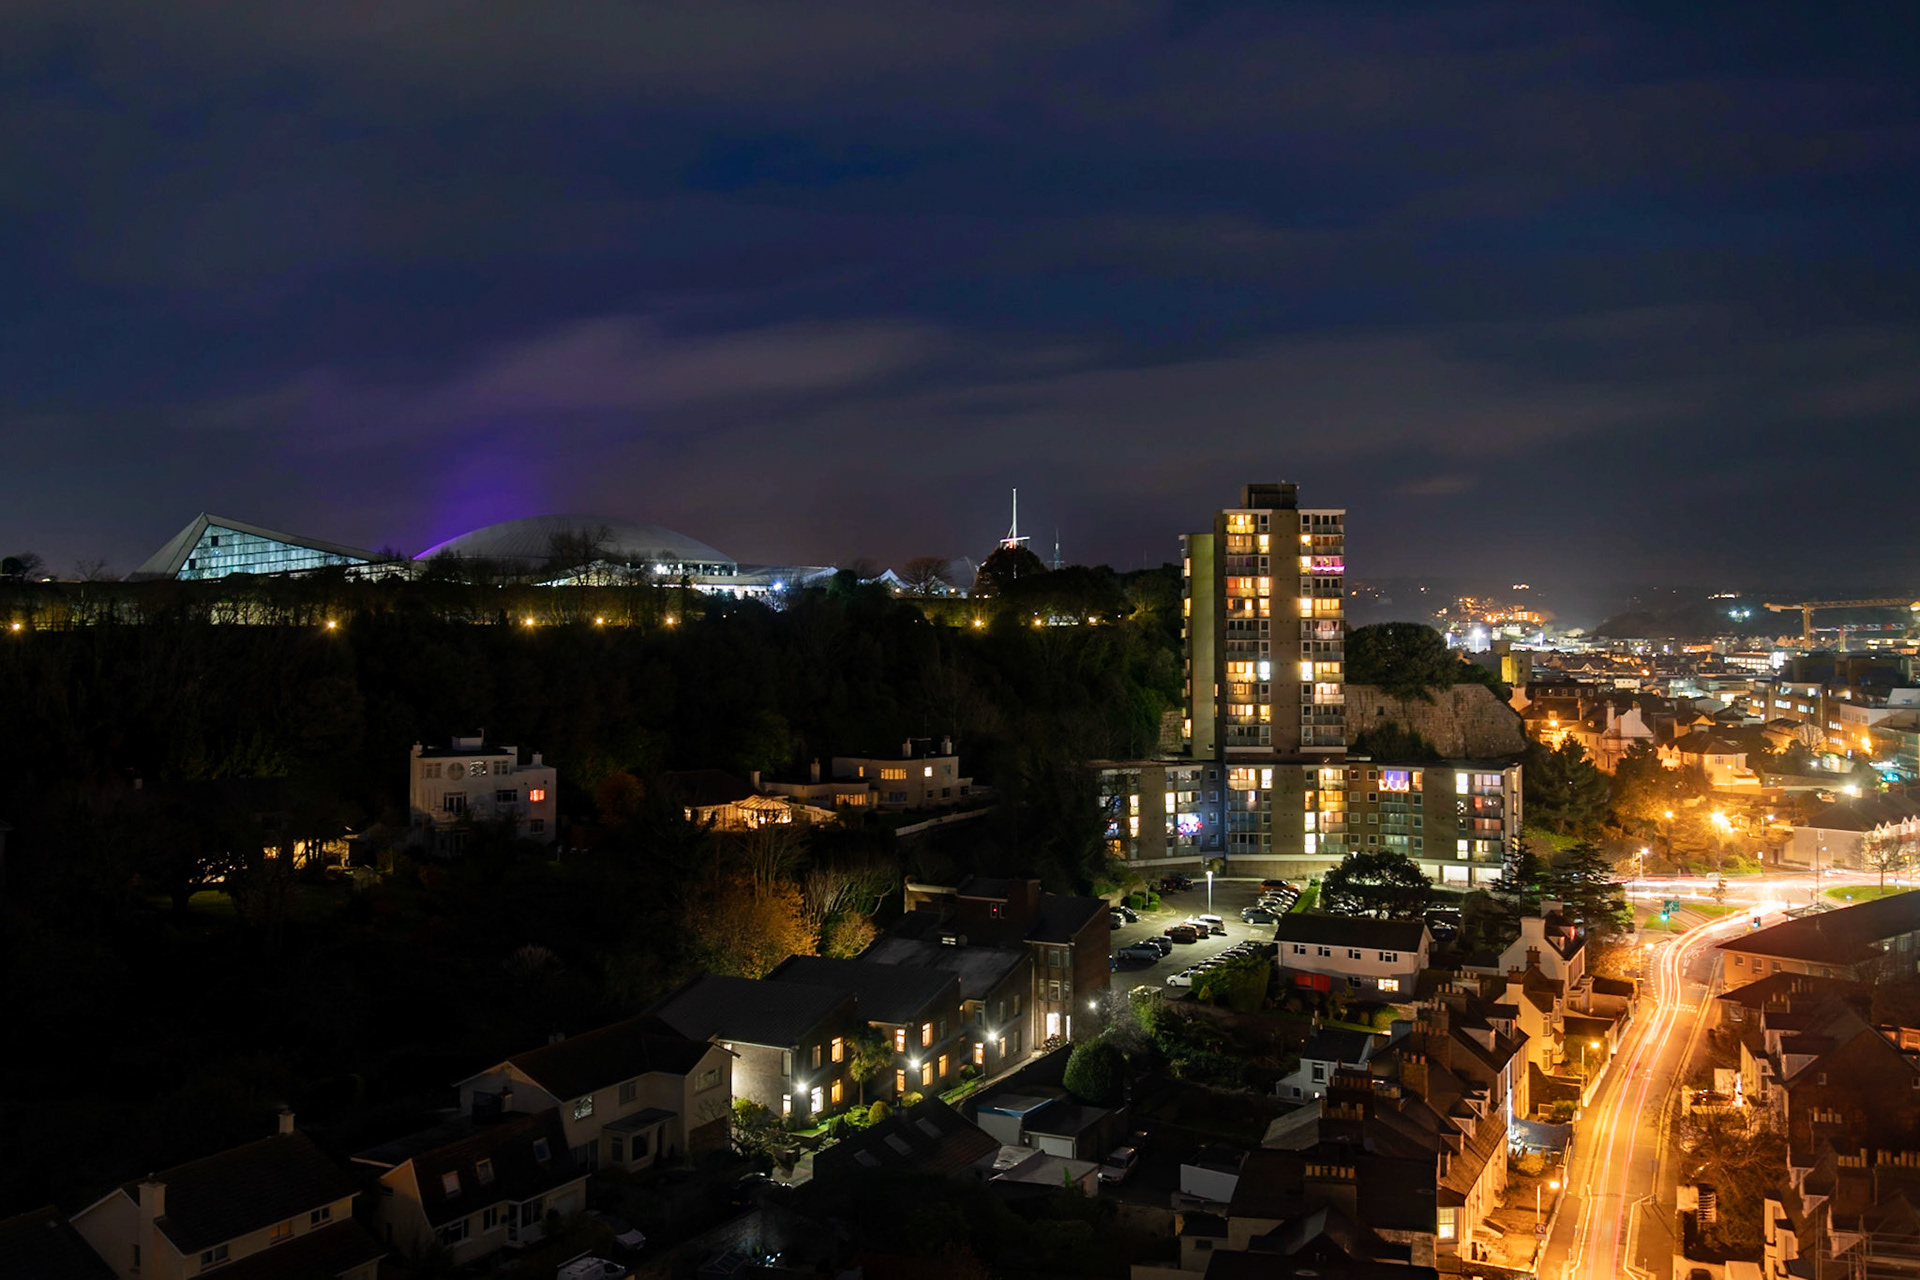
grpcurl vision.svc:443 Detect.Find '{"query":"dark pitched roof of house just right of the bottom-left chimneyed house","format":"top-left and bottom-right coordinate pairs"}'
top-left (353, 1107), bottom-right (586, 1226)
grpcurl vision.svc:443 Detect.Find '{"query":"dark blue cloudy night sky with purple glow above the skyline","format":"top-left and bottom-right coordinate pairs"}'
top-left (0, 0), bottom-right (1920, 587)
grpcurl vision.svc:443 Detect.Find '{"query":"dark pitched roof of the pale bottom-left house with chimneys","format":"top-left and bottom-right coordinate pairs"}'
top-left (110, 1130), bottom-right (359, 1253)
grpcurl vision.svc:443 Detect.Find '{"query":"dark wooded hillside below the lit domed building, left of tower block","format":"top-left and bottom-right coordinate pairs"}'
top-left (0, 568), bottom-right (1179, 1215)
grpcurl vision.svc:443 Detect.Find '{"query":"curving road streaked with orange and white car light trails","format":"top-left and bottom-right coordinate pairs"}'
top-left (1538, 898), bottom-right (1782, 1280)
